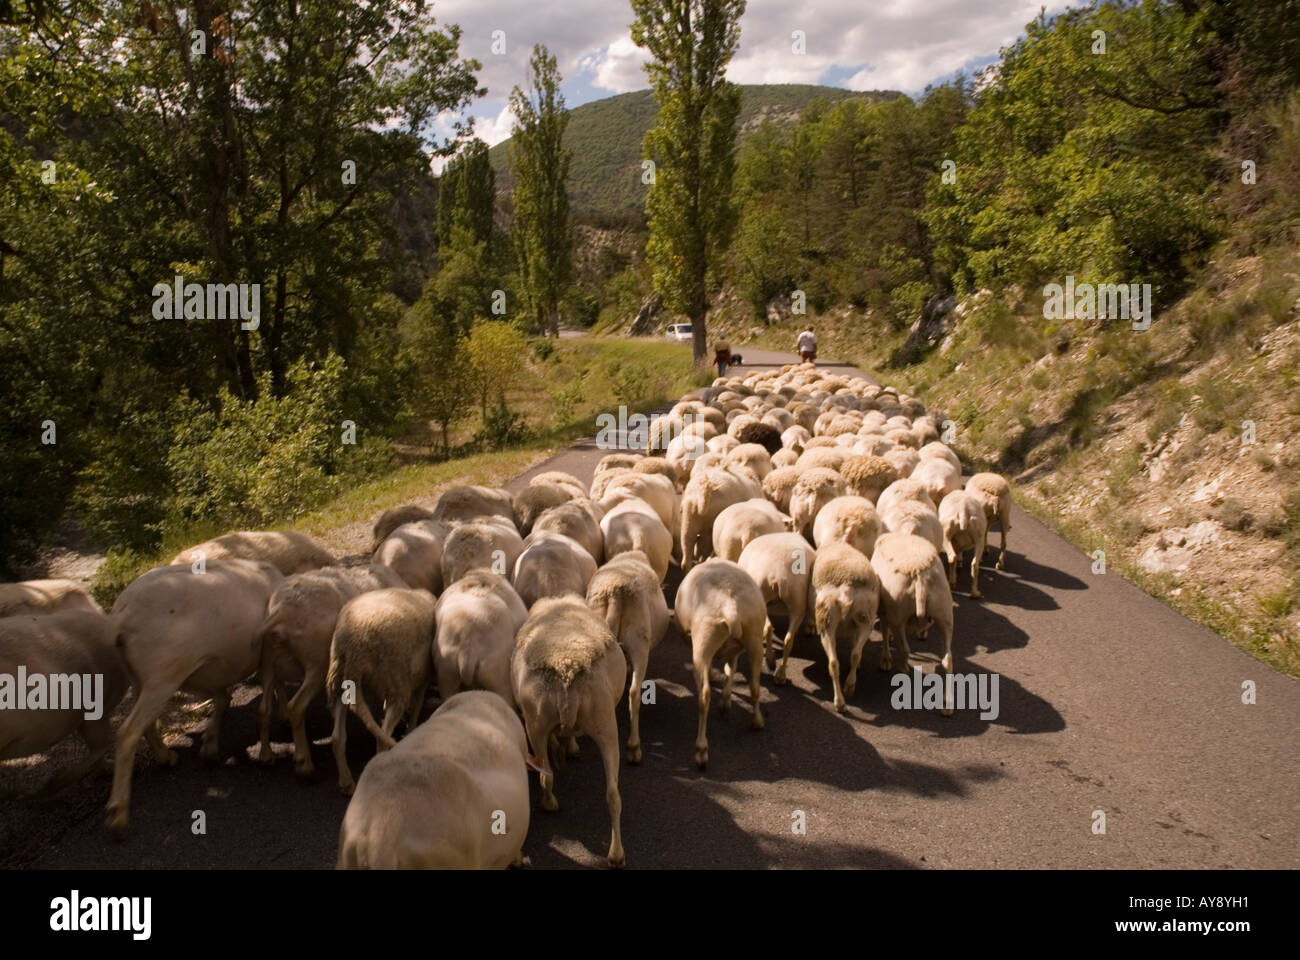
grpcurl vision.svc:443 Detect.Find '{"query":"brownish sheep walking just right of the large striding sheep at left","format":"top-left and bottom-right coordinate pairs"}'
top-left (257, 561), bottom-right (403, 777)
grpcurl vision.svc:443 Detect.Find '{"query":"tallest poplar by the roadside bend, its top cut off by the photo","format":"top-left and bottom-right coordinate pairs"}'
top-left (632, 0), bottom-right (745, 363)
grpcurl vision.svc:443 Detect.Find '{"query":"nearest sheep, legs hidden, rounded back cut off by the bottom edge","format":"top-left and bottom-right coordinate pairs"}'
top-left (338, 691), bottom-right (529, 870)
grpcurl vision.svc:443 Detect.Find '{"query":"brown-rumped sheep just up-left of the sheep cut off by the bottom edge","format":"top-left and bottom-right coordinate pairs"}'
top-left (325, 588), bottom-right (434, 796)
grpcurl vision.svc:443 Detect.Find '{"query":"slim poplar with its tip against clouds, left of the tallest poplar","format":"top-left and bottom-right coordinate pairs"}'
top-left (510, 44), bottom-right (573, 337)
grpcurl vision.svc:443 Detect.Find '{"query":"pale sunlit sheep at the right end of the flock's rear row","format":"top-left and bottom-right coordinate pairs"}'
top-left (871, 533), bottom-right (953, 717)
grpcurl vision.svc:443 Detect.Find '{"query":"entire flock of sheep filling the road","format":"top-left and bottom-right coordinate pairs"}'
top-left (0, 364), bottom-right (1011, 868)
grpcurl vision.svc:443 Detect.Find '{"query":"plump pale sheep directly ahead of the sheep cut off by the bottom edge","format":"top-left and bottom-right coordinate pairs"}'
top-left (433, 570), bottom-right (528, 706)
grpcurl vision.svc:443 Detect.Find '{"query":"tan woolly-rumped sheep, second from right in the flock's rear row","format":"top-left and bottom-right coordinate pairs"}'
top-left (813, 542), bottom-right (880, 713)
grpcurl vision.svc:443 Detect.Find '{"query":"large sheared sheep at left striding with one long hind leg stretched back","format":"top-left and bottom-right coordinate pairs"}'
top-left (107, 559), bottom-right (285, 830)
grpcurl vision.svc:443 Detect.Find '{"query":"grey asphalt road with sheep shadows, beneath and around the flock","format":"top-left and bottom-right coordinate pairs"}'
top-left (0, 350), bottom-right (1300, 868)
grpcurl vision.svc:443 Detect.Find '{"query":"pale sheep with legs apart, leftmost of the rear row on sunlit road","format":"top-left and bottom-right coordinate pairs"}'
top-left (673, 557), bottom-right (767, 767)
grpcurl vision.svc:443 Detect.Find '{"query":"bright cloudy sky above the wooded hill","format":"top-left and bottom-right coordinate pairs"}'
top-left (433, 0), bottom-right (1061, 158)
